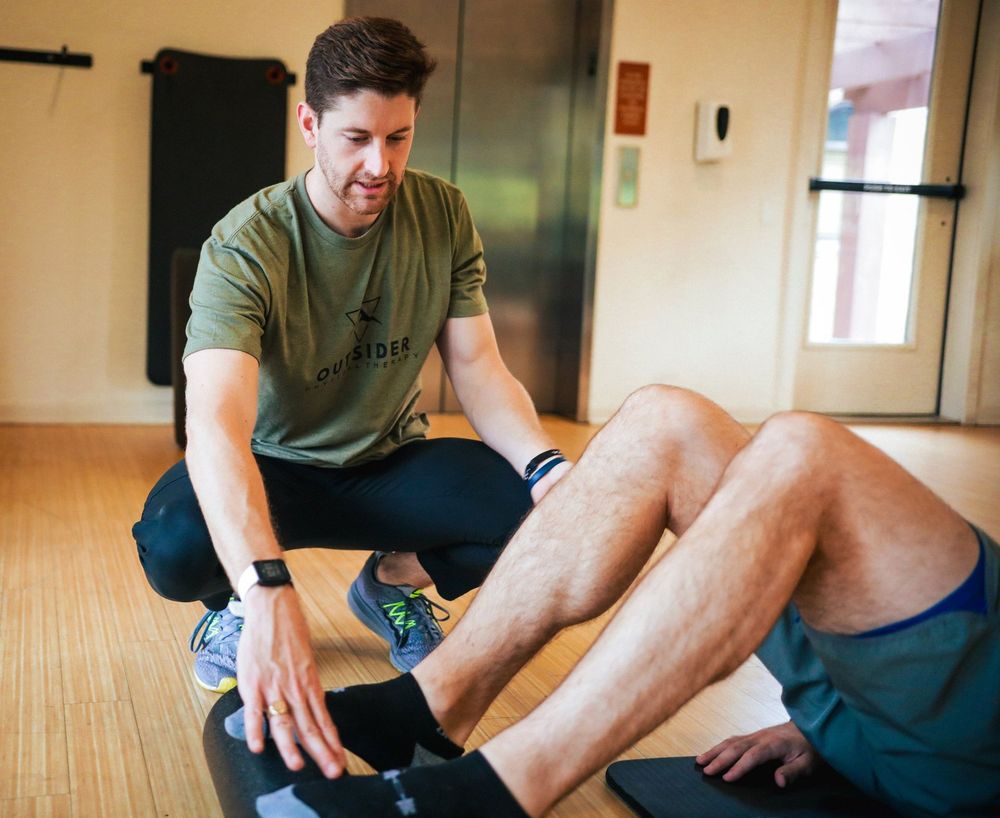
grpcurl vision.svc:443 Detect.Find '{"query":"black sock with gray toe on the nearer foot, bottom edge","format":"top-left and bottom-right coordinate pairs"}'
top-left (257, 751), bottom-right (527, 818)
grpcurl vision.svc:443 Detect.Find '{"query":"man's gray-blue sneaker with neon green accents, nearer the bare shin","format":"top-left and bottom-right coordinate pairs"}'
top-left (347, 551), bottom-right (451, 673)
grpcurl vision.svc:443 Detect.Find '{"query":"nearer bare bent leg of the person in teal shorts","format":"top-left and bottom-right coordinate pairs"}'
top-left (476, 414), bottom-right (976, 815)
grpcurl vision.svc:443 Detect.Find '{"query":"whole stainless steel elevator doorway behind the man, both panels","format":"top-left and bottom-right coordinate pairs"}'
top-left (345, 0), bottom-right (603, 415)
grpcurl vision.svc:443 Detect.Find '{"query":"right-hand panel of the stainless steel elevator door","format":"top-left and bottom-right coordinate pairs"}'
top-left (446, 0), bottom-right (577, 411)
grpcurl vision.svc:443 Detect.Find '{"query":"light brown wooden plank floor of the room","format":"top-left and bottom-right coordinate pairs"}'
top-left (0, 417), bottom-right (1000, 818)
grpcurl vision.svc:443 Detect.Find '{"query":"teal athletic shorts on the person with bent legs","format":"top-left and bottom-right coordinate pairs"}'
top-left (757, 527), bottom-right (1000, 818)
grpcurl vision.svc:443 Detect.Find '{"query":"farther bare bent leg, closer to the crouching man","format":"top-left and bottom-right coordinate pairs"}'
top-left (413, 387), bottom-right (749, 744)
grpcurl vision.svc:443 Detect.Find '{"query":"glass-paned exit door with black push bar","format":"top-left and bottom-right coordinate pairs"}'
top-left (795, 0), bottom-right (979, 415)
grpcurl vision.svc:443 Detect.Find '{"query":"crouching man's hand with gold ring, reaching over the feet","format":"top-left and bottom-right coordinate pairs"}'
top-left (236, 585), bottom-right (347, 778)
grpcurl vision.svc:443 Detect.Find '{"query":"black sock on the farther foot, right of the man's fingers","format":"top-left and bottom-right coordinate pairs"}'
top-left (326, 673), bottom-right (462, 771)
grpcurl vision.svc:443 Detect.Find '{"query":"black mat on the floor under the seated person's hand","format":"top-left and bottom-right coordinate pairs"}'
top-left (605, 756), bottom-right (898, 818)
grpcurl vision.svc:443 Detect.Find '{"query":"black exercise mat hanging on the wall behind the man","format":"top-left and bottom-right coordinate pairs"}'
top-left (146, 48), bottom-right (289, 386)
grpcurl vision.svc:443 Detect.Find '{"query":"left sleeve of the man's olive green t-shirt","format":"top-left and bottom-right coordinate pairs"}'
top-left (184, 237), bottom-right (270, 361)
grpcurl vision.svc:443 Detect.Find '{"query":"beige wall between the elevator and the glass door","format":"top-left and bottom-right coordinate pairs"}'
top-left (590, 0), bottom-right (827, 419)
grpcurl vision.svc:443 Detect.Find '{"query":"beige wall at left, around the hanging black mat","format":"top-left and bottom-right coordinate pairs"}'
top-left (0, 0), bottom-right (342, 422)
